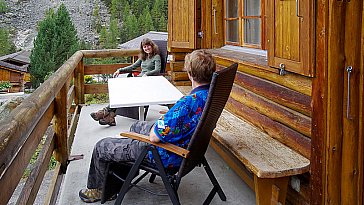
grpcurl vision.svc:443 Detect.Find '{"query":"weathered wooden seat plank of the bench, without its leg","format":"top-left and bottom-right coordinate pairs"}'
top-left (213, 111), bottom-right (310, 178)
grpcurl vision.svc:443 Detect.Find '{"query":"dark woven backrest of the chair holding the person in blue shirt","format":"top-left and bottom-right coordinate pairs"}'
top-left (178, 63), bottom-right (238, 177)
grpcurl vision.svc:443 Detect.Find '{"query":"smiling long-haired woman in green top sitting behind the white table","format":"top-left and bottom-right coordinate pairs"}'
top-left (91, 38), bottom-right (161, 126)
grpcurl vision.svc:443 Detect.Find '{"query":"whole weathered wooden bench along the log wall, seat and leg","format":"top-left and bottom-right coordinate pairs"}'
top-left (210, 110), bottom-right (310, 205)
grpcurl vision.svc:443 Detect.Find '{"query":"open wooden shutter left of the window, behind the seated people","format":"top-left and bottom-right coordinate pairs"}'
top-left (168, 0), bottom-right (197, 49)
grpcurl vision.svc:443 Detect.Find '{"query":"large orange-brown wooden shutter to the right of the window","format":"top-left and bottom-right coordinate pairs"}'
top-left (267, 0), bottom-right (314, 77)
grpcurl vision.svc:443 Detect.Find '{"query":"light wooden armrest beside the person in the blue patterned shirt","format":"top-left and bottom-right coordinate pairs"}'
top-left (120, 132), bottom-right (190, 158)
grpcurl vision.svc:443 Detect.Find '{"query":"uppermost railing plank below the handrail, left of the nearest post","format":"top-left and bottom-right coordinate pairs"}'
top-left (0, 104), bottom-right (54, 204)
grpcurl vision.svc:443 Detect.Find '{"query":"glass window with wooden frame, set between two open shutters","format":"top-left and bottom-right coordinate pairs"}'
top-left (224, 0), bottom-right (266, 49)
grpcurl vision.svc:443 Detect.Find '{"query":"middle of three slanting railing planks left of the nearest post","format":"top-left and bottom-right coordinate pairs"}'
top-left (16, 127), bottom-right (55, 204)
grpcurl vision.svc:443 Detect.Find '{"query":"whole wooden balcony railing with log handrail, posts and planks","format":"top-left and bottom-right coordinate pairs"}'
top-left (0, 49), bottom-right (138, 204)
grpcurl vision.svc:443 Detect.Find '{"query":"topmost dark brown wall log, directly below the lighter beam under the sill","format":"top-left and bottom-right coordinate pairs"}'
top-left (235, 72), bottom-right (312, 116)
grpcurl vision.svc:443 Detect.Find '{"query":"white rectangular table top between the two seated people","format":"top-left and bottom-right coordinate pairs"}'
top-left (108, 76), bottom-right (183, 108)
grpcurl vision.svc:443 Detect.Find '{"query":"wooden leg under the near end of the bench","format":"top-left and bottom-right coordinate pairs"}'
top-left (254, 175), bottom-right (289, 205)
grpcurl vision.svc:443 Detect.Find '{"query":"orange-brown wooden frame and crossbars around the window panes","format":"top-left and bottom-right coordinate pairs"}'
top-left (223, 0), bottom-right (267, 50)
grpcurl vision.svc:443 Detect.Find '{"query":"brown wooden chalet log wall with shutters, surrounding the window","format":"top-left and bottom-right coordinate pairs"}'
top-left (168, 0), bottom-right (364, 204)
